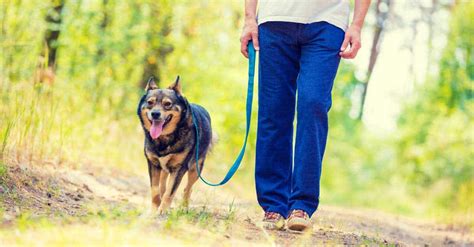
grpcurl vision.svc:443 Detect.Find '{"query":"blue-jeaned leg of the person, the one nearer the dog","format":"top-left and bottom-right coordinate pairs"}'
top-left (255, 22), bottom-right (300, 217)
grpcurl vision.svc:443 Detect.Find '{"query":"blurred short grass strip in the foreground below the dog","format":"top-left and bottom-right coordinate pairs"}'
top-left (0, 201), bottom-right (252, 246)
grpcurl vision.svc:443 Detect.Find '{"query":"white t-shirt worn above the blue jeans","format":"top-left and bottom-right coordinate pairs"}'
top-left (257, 0), bottom-right (350, 31)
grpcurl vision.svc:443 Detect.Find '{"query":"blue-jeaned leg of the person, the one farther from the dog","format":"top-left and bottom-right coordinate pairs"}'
top-left (290, 22), bottom-right (344, 216)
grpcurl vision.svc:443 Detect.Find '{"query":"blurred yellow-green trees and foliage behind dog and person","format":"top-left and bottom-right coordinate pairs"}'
top-left (0, 0), bottom-right (474, 224)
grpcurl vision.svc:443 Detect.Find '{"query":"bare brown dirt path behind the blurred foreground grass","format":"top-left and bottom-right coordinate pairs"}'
top-left (0, 163), bottom-right (474, 246)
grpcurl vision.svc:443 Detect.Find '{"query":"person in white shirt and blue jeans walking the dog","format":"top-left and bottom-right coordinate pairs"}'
top-left (241, 0), bottom-right (370, 231)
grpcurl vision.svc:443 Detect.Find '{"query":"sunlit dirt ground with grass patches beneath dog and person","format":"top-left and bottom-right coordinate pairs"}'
top-left (0, 162), bottom-right (474, 246)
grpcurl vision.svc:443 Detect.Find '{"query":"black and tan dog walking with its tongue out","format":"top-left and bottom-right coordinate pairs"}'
top-left (137, 76), bottom-right (212, 214)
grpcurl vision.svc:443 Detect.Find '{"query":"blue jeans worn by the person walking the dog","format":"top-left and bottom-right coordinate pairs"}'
top-left (255, 22), bottom-right (344, 217)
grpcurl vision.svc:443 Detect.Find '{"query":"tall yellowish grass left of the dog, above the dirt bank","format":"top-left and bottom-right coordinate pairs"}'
top-left (0, 76), bottom-right (141, 168)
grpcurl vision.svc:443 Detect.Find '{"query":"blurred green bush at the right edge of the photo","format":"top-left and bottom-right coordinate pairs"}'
top-left (396, 2), bottom-right (474, 224)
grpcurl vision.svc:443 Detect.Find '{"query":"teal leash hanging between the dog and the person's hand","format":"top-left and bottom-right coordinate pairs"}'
top-left (191, 42), bottom-right (255, 186)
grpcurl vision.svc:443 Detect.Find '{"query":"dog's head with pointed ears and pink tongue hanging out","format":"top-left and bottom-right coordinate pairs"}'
top-left (138, 76), bottom-right (189, 139)
